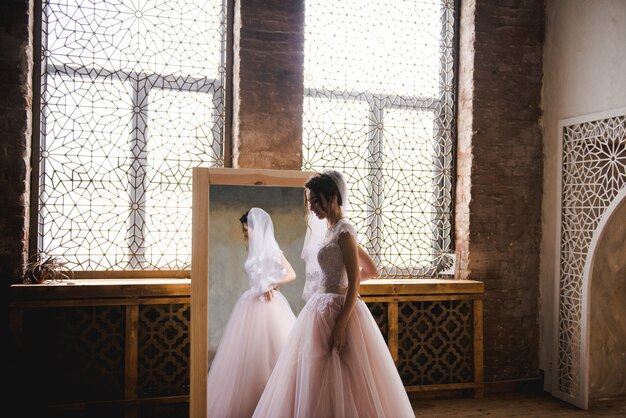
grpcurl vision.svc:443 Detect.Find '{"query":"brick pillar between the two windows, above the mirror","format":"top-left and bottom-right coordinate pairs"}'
top-left (233, 0), bottom-right (304, 170)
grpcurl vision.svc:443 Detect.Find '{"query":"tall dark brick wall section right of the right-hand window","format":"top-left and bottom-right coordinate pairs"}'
top-left (464, 0), bottom-right (545, 382)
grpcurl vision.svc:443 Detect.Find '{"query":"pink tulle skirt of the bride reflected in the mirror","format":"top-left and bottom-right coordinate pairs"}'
top-left (207, 290), bottom-right (296, 418)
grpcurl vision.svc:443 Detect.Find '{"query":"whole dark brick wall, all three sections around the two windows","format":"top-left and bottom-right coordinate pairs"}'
top-left (0, 0), bottom-right (544, 382)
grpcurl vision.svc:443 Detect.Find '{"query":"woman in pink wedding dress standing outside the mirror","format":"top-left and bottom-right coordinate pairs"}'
top-left (253, 170), bottom-right (415, 418)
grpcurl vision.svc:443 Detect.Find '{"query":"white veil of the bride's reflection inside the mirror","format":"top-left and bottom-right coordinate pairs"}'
top-left (244, 208), bottom-right (287, 297)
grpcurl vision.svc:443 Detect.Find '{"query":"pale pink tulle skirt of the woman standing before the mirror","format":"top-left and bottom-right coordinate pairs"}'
top-left (253, 293), bottom-right (415, 418)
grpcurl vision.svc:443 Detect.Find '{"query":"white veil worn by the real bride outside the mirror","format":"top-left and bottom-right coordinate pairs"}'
top-left (301, 168), bottom-right (348, 302)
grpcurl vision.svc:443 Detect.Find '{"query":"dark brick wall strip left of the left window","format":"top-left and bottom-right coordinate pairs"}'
top-left (0, 0), bottom-right (33, 290)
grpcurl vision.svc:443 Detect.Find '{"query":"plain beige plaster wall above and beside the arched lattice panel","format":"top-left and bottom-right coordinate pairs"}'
top-left (539, 0), bottom-right (626, 391)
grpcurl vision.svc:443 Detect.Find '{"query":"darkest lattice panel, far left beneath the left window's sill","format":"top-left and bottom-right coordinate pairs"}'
top-left (18, 306), bottom-right (125, 405)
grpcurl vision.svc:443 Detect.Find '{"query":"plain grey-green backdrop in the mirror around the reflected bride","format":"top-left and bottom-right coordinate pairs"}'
top-left (209, 185), bottom-right (306, 360)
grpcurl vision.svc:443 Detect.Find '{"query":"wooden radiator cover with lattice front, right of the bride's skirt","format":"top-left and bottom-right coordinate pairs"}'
top-left (361, 279), bottom-right (484, 397)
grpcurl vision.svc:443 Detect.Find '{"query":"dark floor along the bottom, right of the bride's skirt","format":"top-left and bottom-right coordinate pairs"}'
top-left (413, 393), bottom-right (626, 418)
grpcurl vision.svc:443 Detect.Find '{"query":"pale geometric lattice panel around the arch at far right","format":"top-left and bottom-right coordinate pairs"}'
top-left (555, 110), bottom-right (626, 400)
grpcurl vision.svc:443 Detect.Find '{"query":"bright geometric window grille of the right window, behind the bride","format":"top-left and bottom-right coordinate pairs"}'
top-left (302, 0), bottom-right (456, 277)
